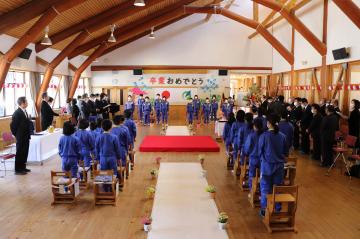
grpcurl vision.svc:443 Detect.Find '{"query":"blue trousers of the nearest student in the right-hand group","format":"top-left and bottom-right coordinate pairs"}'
top-left (260, 168), bottom-right (284, 210)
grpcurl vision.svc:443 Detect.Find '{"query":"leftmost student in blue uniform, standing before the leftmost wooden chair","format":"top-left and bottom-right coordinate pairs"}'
top-left (59, 121), bottom-right (81, 178)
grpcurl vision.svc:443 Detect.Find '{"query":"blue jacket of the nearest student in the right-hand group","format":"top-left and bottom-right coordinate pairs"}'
top-left (259, 130), bottom-right (289, 176)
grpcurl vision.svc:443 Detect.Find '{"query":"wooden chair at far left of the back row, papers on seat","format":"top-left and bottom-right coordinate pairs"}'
top-left (51, 171), bottom-right (80, 205)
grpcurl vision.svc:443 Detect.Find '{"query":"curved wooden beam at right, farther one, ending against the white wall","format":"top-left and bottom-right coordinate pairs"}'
top-left (185, 7), bottom-right (294, 65)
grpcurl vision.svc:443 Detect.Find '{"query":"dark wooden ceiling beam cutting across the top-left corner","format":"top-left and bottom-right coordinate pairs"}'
top-left (0, 0), bottom-right (61, 34)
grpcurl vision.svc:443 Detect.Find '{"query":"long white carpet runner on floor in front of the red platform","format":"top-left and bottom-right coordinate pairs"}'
top-left (148, 163), bottom-right (228, 239)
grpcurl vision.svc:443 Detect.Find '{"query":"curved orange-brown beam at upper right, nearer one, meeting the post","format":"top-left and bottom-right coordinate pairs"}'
top-left (253, 0), bottom-right (327, 56)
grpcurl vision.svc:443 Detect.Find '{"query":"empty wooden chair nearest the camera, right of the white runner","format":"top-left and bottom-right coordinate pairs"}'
top-left (263, 185), bottom-right (298, 233)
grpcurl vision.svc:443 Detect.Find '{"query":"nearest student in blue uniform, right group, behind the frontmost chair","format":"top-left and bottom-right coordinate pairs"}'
top-left (259, 114), bottom-right (289, 216)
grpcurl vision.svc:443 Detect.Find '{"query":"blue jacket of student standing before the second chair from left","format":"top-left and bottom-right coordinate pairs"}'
top-left (96, 132), bottom-right (121, 160)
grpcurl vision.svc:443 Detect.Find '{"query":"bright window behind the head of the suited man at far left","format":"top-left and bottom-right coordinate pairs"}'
top-left (0, 70), bottom-right (35, 117)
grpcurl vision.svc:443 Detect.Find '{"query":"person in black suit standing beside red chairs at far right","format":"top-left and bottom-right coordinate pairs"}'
top-left (320, 105), bottom-right (339, 167)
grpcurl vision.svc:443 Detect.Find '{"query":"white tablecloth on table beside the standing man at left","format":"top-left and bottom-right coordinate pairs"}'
top-left (28, 129), bottom-right (62, 162)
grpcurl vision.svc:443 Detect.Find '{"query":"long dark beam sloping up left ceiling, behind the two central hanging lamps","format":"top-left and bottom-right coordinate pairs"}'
top-left (69, 0), bottom-right (194, 59)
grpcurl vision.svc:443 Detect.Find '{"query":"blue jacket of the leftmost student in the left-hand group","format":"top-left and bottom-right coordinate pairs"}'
top-left (58, 135), bottom-right (82, 159)
